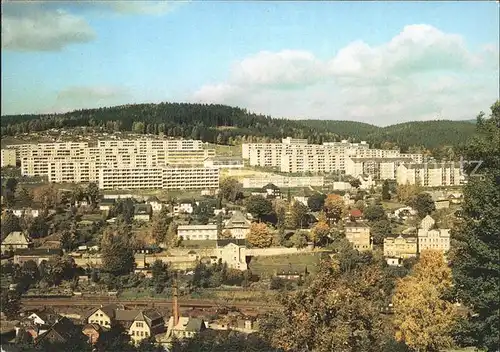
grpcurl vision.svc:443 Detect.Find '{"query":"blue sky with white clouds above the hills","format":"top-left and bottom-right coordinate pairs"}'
top-left (1, 0), bottom-right (500, 126)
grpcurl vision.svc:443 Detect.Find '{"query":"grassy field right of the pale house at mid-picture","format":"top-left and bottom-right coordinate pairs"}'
top-left (249, 253), bottom-right (321, 277)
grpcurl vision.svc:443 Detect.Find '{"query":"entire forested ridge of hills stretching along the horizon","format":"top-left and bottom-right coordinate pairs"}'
top-left (1, 103), bottom-right (475, 150)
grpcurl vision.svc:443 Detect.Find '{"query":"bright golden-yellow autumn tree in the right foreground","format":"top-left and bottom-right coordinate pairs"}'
top-left (392, 250), bottom-right (457, 352)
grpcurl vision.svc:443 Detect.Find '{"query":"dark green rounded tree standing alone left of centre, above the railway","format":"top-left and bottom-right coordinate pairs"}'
top-left (101, 228), bottom-right (135, 275)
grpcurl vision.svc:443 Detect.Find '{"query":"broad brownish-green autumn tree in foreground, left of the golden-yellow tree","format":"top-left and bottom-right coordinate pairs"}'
top-left (259, 260), bottom-right (384, 352)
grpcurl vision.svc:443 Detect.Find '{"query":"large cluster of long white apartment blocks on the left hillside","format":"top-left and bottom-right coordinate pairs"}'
top-left (2, 140), bottom-right (219, 189)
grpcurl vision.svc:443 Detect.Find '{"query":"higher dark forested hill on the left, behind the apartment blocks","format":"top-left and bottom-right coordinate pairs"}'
top-left (1, 103), bottom-right (339, 143)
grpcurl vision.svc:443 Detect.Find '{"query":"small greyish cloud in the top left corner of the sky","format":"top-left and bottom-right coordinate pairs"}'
top-left (2, 4), bottom-right (95, 51)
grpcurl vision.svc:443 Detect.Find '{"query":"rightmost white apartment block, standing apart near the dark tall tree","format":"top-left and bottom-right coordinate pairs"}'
top-left (396, 162), bottom-right (463, 187)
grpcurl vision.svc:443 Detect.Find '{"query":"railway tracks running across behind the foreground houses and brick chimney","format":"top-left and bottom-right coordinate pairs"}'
top-left (21, 297), bottom-right (278, 312)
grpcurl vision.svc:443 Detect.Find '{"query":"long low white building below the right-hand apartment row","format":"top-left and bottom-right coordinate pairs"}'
top-left (242, 174), bottom-right (325, 188)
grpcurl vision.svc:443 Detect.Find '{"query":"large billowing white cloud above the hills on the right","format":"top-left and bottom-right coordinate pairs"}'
top-left (192, 24), bottom-right (498, 125)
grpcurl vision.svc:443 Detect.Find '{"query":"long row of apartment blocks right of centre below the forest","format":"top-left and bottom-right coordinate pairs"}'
top-left (242, 138), bottom-right (423, 175)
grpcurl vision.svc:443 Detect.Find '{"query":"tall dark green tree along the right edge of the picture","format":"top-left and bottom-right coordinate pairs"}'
top-left (450, 101), bottom-right (500, 351)
